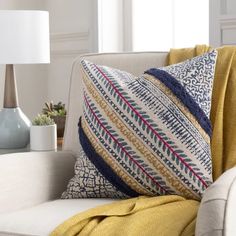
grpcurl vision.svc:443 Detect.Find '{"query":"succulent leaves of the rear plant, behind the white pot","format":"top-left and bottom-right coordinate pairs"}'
top-left (43, 102), bottom-right (66, 117)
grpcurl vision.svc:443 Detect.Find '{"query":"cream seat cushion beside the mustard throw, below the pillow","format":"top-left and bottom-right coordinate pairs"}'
top-left (0, 199), bottom-right (114, 236)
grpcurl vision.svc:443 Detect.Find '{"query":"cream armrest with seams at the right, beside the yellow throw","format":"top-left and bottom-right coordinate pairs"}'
top-left (196, 167), bottom-right (236, 236)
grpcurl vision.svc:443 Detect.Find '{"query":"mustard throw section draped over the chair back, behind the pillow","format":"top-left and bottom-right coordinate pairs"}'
top-left (168, 45), bottom-right (236, 180)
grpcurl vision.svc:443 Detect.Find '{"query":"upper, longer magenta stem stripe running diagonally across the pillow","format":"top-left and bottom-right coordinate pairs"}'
top-left (93, 64), bottom-right (208, 188)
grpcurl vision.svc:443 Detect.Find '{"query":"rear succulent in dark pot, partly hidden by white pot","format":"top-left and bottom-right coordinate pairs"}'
top-left (43, 102), bottom-right (66, 138)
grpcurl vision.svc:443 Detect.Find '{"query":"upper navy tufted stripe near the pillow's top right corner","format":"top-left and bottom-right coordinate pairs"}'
top-left (144, 68), bottom-right (212, 136)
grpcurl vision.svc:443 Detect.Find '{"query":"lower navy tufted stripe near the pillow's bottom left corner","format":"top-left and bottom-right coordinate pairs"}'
top-left (79, 118), bottom-right (140, 197)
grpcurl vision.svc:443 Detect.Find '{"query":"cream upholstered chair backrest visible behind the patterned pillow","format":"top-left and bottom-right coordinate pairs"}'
top-left (64, 52), bottom-right (167, 153)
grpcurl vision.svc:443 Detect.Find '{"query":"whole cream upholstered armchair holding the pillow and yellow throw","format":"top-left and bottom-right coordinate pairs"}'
top-left (0, 52), bottom-right (236, 236)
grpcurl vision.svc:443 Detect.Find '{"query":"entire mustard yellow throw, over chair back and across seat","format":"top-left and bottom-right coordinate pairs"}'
top-left (51, 45), bottom-right (236, 236)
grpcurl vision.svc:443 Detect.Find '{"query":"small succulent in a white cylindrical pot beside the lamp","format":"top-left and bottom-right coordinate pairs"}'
top-left (30, 114), bottom-right (57, 151)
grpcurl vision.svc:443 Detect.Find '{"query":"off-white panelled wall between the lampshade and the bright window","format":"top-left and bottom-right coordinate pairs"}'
top-left (46, 0), bottom-right (97, 109)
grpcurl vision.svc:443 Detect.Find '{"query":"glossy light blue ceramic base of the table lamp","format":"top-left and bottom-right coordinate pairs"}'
top-left (0, 107), bottom-right (31, 149)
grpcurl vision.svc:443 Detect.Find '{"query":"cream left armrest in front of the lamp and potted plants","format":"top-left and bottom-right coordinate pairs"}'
top-left (0, 152), bottom-right (75, 213)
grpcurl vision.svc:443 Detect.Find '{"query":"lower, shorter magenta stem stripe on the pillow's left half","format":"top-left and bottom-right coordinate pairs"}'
top-left (84, 94), bottom-right (170, 194)
